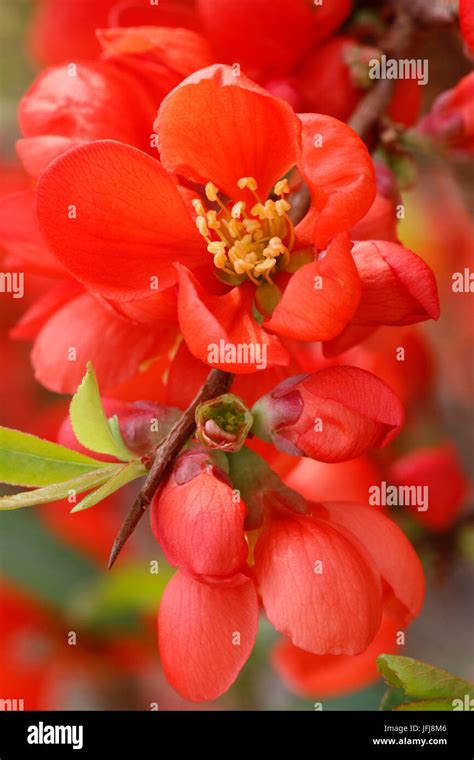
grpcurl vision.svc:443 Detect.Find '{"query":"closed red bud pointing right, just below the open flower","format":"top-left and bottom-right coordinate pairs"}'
top-left (252, 367), bottom-right (403, 462)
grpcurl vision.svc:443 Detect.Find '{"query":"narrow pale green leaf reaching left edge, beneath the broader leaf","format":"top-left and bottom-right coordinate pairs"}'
top-left (0, 464), bottom-right (122, 511)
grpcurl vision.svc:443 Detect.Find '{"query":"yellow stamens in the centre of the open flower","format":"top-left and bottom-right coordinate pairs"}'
top-left (193, 177), bottom-right (295, 285)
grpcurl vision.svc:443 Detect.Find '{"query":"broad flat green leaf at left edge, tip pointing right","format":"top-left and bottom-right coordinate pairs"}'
top-left (0, 427), bottom-right (104, 486)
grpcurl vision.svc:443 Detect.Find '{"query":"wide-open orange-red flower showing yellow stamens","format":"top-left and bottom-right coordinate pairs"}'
top-left (38, 66), bottom-right (374, 372)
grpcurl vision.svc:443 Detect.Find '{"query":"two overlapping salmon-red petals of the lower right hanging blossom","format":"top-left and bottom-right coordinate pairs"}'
top-left (255, 500), bottom-right (424, 655)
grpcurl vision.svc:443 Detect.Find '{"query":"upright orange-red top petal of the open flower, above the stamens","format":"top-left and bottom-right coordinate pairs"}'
top-left (155, 65), bottom-right (301, 199)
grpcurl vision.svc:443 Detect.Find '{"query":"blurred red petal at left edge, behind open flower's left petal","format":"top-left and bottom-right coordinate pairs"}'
top-left (0, 190), bottom-right (66, 277)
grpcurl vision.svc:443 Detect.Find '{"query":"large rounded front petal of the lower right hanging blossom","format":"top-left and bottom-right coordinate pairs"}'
top-left (255, 510), bottom-right (381, 654)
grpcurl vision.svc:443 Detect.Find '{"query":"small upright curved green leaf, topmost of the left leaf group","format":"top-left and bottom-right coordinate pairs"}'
top-left (69, 362), bottom-right (134, 462)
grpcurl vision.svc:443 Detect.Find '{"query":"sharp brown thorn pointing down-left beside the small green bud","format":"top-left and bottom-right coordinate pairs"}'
top-left (108, 369), bottom-right (233, 570)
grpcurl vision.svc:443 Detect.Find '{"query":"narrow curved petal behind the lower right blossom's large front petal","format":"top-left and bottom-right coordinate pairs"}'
top-left (316, 502), bottom-right (425, 624)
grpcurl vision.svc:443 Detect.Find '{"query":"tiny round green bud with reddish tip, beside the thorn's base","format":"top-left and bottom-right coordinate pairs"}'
top-left (196, 393), bottom-right (253, 452)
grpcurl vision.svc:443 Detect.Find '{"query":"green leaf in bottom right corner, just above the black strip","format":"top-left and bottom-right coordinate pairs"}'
top-left (377, 654), bottom-right (474, 700)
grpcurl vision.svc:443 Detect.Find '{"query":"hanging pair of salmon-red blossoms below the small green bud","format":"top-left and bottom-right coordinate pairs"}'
top-left (151, 434), bottom-right (424, 701)
